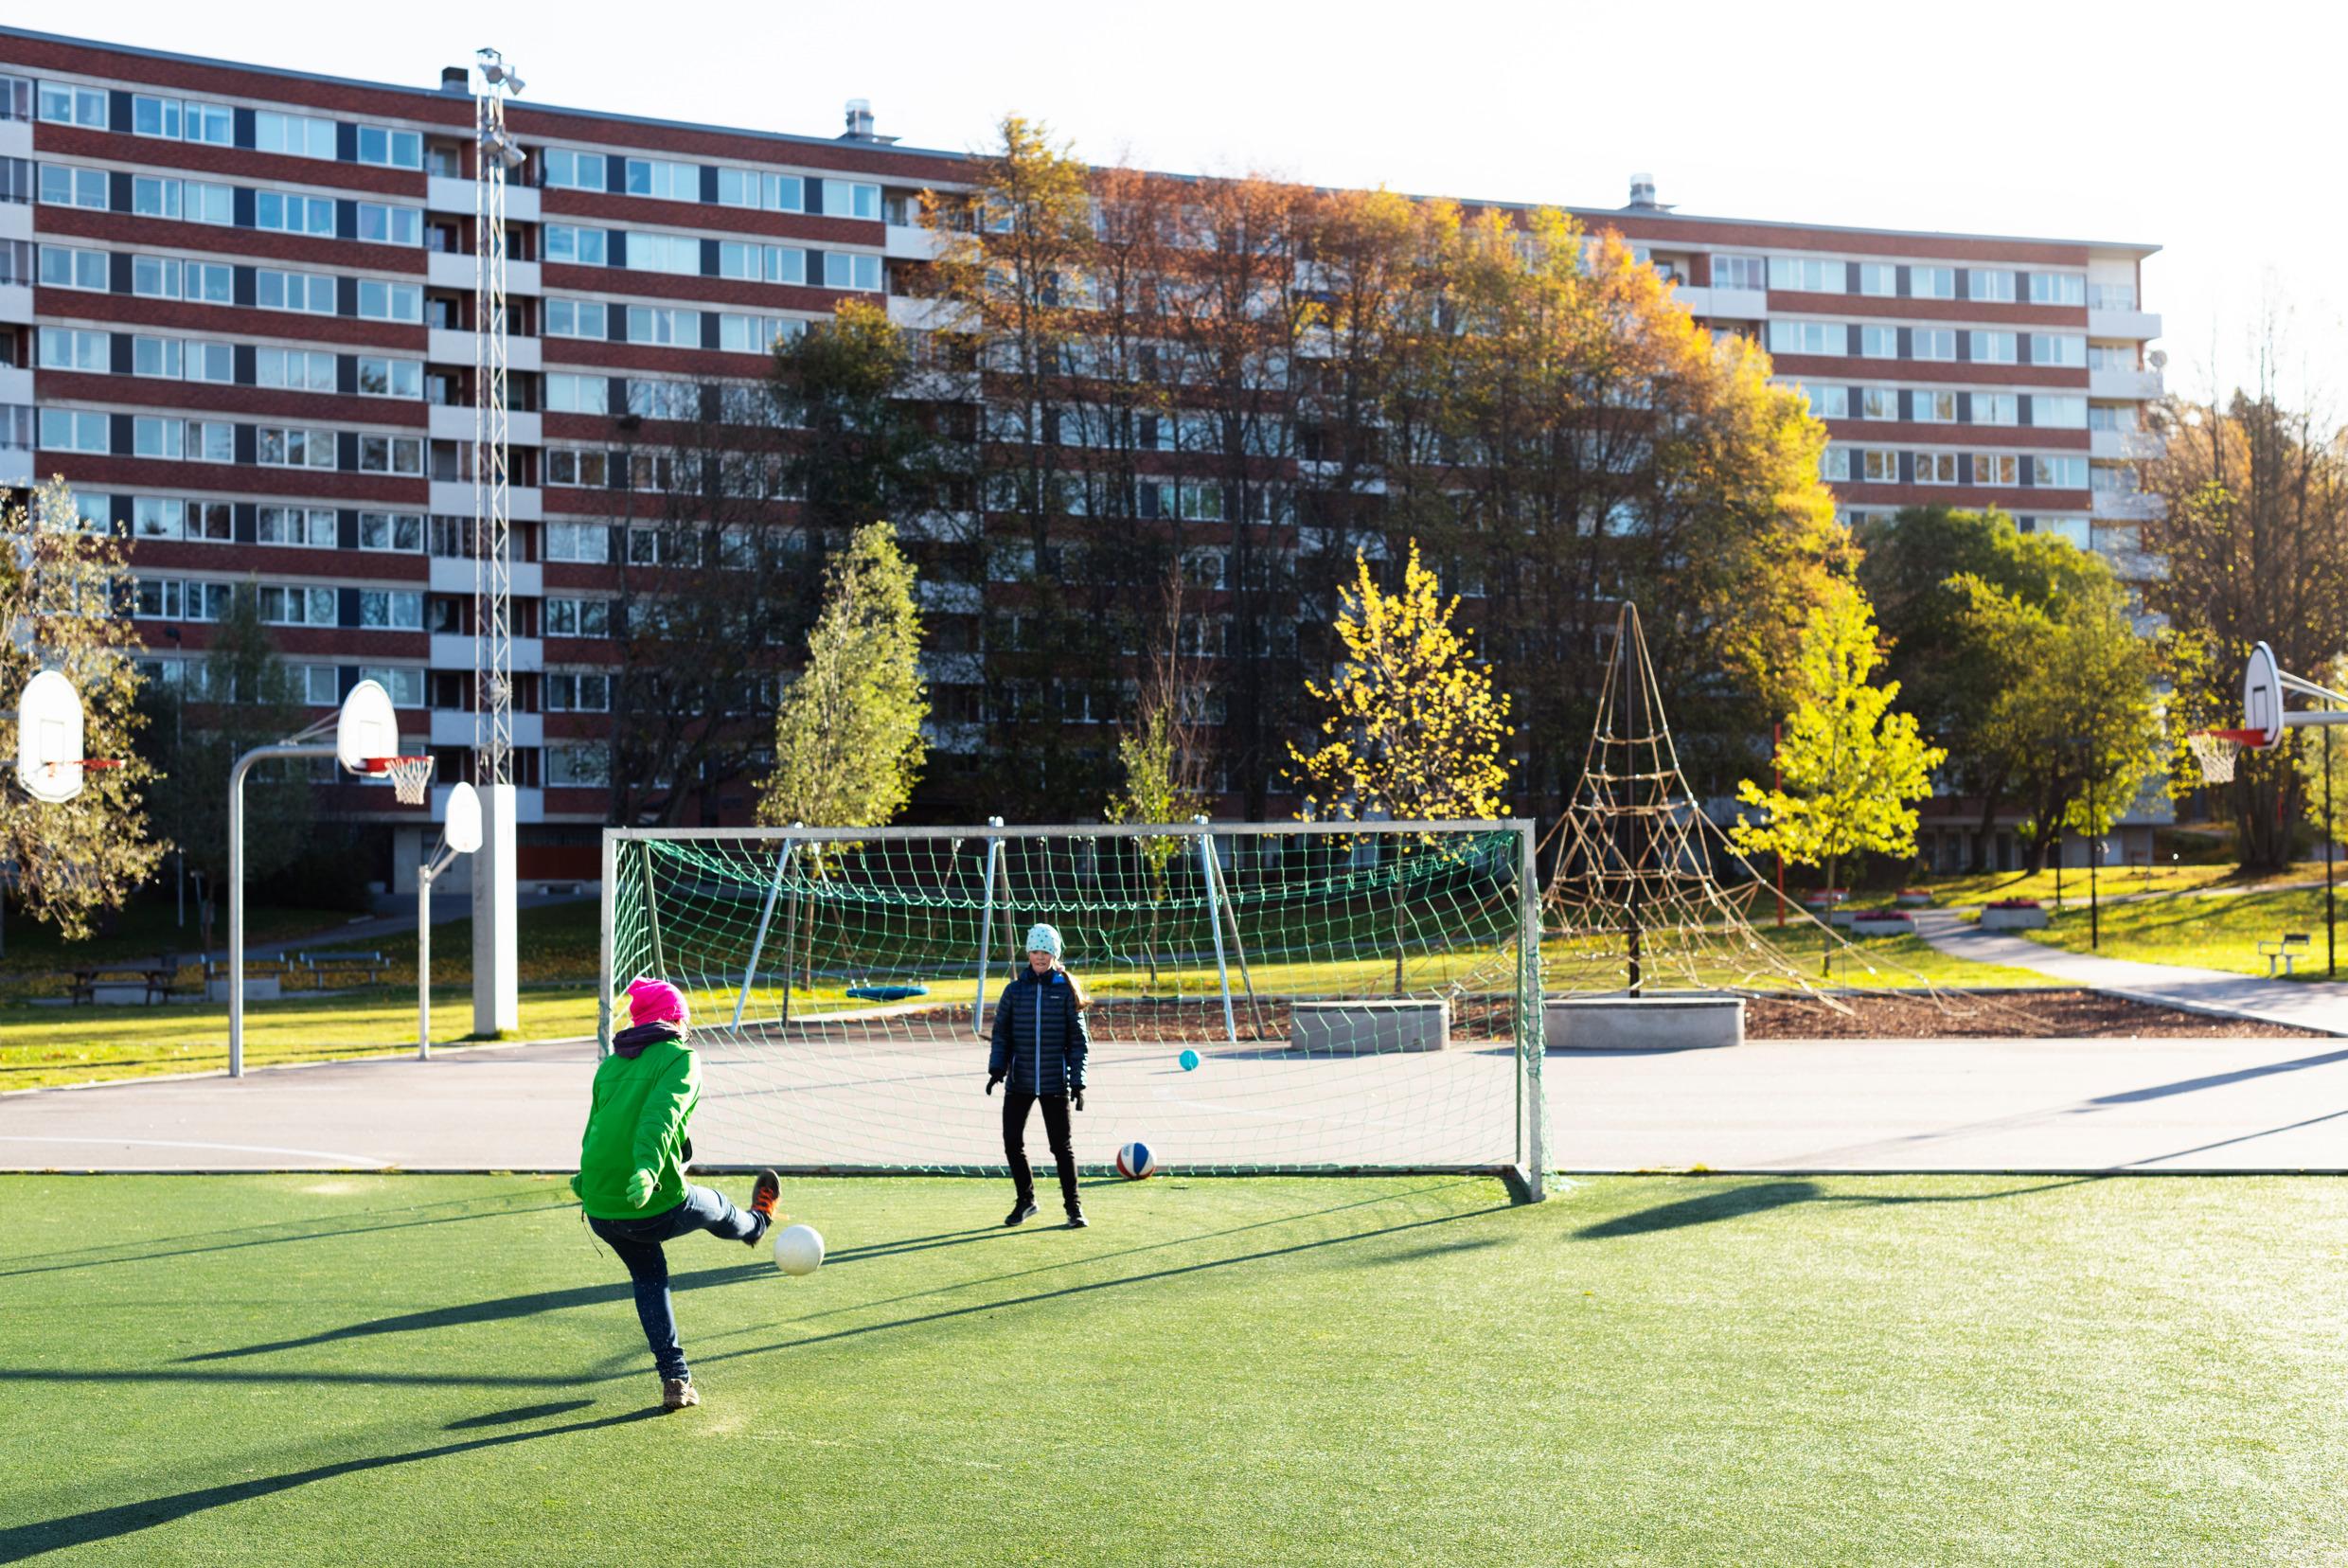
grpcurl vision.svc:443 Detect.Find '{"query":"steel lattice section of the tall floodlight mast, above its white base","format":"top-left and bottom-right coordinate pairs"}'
top-left (471, 49), bottom-right (522, 784)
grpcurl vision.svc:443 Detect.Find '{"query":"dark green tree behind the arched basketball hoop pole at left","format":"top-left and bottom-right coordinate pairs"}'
top-left (148, 582), bottom-right (312, 951)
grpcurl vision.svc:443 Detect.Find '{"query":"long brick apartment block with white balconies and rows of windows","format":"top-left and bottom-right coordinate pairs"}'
top-left (0, 28), bottom-right (2161, 885)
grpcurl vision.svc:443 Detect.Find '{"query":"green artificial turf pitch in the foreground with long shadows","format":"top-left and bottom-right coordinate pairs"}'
top-left (0, 1176), bottom-right (2348, 1566)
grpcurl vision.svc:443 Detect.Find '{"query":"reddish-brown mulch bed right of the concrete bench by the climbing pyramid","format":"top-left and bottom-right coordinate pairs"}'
top-left (1745, 990), bottom-right (2329, 1040)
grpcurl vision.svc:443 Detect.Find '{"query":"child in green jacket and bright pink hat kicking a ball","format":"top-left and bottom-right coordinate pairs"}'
top-left (571, 979), bottom-right (782, 1411)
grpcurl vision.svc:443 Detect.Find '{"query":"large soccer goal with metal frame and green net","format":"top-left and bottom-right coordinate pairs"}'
top-left (601, 822), bottom-right (1542, 1197)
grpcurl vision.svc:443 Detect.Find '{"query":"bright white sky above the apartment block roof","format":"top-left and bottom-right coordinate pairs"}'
top-left (36, 0), bottom-right (2348, 416)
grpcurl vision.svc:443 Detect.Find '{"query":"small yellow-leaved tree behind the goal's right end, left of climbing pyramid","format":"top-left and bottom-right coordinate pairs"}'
top-left (1290, 540), bottom-right (1515, 822)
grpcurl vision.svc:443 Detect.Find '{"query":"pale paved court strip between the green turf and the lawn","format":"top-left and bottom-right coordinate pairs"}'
top-left (0, 1038), bottom-right (2348, 1171)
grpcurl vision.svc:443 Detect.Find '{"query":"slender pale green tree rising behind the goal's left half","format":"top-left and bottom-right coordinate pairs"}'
top-left (758, 524), bottom-right (930, 829)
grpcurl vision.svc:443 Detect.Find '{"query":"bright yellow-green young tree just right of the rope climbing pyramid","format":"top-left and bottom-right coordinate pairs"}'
top-left (1731, 592), bottom-right (1947, 929)
